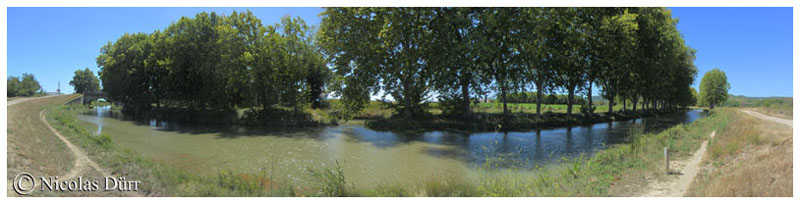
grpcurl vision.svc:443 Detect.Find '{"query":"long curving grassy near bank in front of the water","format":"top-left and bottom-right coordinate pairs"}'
top-left (42, 103), bottom-right (732, 196)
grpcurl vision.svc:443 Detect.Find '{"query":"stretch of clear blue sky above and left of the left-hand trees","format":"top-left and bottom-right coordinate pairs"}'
top-left (7, 8), bottom-right (322, 93)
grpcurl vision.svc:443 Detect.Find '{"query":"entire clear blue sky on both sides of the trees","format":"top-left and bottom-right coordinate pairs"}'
top-left (7, 8), bottom-right (793, 96)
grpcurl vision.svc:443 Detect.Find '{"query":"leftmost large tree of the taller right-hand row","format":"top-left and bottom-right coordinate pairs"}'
top-left (319, 8), bottom-right (433, 118)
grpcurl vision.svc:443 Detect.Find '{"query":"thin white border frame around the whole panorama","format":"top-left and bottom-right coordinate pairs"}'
top-left (0, 0), bottom-right (800, 204)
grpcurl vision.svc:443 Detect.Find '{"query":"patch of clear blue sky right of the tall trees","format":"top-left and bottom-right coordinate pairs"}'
top-left (671, 8), bottom-right (793, 96)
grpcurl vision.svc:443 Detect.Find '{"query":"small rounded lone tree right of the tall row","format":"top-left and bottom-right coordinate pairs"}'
top-left (700, 68), bottom-right (731, 109)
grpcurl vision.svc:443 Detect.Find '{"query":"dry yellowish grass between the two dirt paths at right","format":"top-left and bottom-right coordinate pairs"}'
top-left (689, 109), bottom-right (793, 196)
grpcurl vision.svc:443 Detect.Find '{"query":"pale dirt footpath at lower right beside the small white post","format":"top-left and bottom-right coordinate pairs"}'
top-left (641, 131), bottom-right (717, 197)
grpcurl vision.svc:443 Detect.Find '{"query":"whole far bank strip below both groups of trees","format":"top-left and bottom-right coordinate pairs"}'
top-left (114, 100), bottom-right (644, 132)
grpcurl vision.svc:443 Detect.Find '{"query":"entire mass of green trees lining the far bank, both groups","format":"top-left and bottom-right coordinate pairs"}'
top-left (97, 7), bottom-right (697, 122)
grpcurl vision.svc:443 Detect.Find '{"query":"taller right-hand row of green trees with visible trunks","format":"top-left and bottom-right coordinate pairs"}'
top-left (318, 8), bottom-right (697, 117)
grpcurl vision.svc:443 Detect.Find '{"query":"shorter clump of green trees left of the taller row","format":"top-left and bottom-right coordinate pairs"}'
top-left (97, 11), bottom-right (329, 115)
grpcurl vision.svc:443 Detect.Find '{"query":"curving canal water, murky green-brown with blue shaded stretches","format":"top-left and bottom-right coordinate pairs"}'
top-left (77, 107), bottom-right (704, 185)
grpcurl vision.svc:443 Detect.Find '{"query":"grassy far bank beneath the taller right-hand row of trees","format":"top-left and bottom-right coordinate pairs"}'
top-left (354, 101), bottom-right (677, 132)
